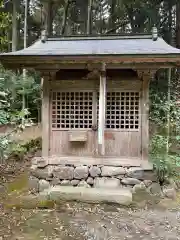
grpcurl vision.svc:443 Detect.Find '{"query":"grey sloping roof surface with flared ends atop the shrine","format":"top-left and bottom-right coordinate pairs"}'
top-left (0, 35), bottom-right (180, 58)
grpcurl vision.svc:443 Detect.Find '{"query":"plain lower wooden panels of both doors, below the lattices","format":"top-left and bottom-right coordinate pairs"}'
top-left (50, 129), bottom-right (141, 158)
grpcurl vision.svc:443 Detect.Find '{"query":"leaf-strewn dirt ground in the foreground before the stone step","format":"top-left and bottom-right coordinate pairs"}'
top-left (0, 203), bottom-right (180, 240)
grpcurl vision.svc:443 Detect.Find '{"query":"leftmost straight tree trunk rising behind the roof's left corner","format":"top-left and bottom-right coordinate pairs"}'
top-left (12, 0), bottom-right (18, 52)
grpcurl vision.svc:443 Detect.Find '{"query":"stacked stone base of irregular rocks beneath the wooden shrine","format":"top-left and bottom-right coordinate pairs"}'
top-left (29, 158), bottom-right (156, 192)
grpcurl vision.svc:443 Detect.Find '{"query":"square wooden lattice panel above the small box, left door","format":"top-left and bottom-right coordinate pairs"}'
top-left (52, 91), bottom-right (93, 129)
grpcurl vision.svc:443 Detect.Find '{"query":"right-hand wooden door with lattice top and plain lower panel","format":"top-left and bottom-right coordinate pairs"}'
top-left (97, 91), bottom-right (141, 158)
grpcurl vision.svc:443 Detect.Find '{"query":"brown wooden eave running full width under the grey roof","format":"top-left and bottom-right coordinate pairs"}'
top-left (0, 54), bottom-right (180, 69)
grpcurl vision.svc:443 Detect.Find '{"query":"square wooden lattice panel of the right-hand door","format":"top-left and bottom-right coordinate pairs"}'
top-left (97, 92), bottom-right (140, 131)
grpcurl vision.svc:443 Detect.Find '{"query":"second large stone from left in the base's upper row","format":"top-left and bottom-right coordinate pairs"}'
top-left (53, 166), bottom-right (74, 180)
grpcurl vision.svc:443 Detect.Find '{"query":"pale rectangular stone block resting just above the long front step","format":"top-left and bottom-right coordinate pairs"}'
top-left (94, 177), bottom-right (120, 188)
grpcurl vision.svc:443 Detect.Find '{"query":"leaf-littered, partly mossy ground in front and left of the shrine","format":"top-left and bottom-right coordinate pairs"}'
top-left (0, 153), bottom-right (180, 240)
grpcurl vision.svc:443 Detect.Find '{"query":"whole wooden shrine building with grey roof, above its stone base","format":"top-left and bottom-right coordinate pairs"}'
top-left (0, 32), bottom-right (180, 168)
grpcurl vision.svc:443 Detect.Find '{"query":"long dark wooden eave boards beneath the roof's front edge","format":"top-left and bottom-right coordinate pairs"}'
top-left (1, 54), bottom-right (180, 68)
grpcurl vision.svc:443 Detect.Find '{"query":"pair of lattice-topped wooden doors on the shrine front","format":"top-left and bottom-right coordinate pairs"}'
top-left (51, 90), bottom-right (141, 156)
